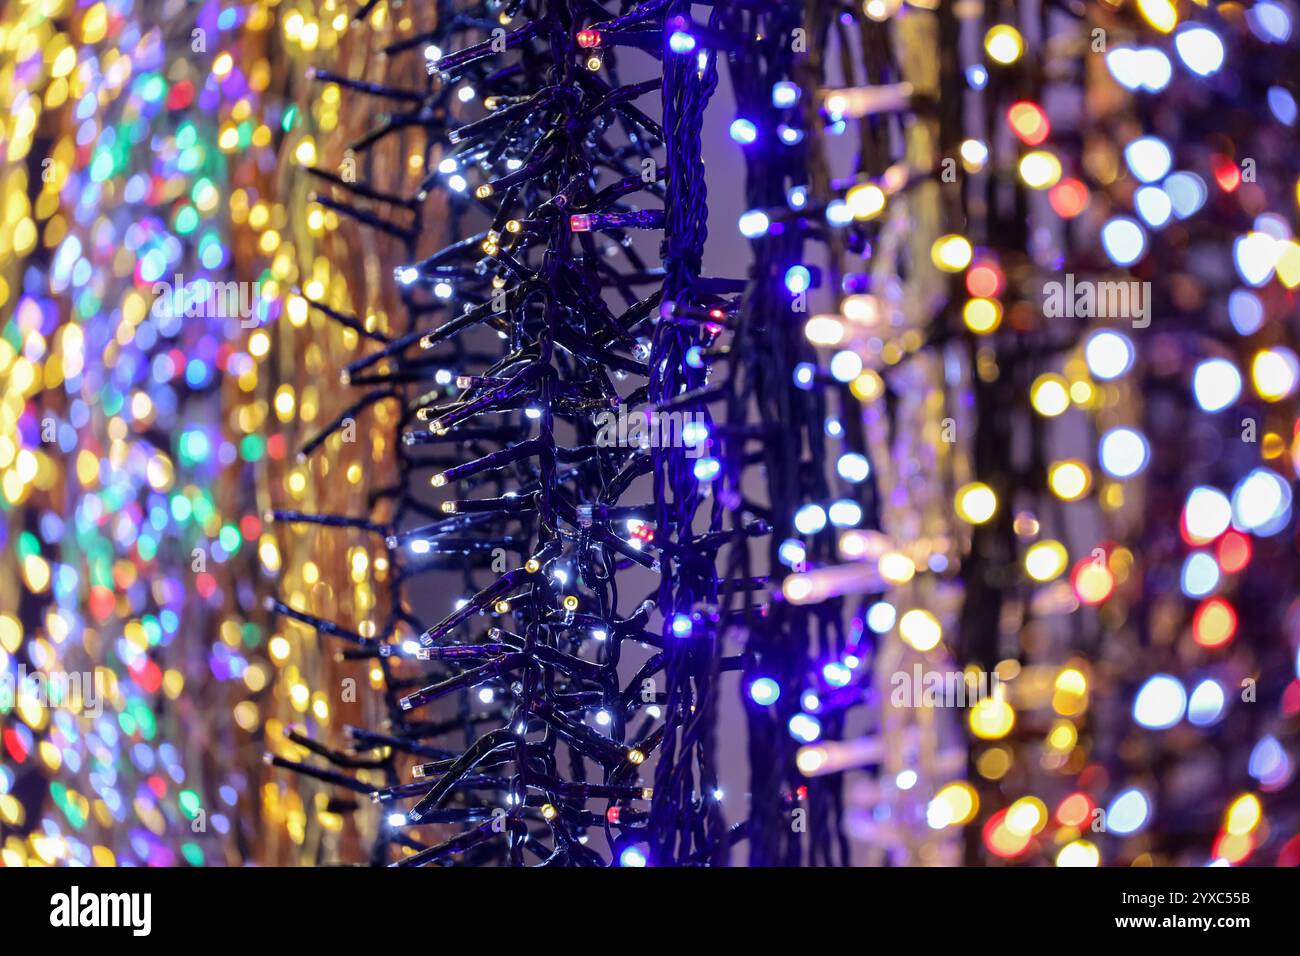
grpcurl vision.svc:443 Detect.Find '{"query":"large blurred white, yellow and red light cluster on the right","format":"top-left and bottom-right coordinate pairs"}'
top-left (780, 3), bottom-right (1300, 866)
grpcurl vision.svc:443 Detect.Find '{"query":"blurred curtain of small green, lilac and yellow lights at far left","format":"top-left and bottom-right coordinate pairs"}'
top-left (0, 0), bottom-right (270, 865)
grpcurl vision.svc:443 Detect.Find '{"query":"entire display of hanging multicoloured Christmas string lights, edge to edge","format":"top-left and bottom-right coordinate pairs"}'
top-left (0, 0), bottom-right (1300, 868)
